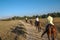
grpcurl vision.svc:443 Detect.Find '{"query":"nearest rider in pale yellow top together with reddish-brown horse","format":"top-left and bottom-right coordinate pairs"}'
top-left (41, 15), bottom-right (56, 40)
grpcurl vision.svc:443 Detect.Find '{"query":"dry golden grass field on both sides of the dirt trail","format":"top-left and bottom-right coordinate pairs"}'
top-left (0, 18), bottom-right (60, 40)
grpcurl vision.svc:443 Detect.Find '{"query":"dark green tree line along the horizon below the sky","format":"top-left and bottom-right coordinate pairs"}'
top-left (2, 12), bottom-right (60, 21)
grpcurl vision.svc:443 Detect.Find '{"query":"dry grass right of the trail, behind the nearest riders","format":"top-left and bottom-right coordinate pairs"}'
top-left (33, 18), bottom-right (60, 40)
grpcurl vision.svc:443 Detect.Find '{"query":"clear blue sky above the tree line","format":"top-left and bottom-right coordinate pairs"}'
top-left (0, 0), bottom-right (60, 18)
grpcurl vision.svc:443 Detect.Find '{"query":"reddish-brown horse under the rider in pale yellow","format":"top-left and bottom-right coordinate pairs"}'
top-left (41, 24), bottom-right (57, 40)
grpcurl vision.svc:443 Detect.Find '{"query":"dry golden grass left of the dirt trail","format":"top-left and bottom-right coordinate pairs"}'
top-left (0, 20), bottom-right (22, 40)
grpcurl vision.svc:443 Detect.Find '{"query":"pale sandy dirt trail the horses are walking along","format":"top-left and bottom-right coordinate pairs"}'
top-left (20, 20), bottom-right (57, 40)
